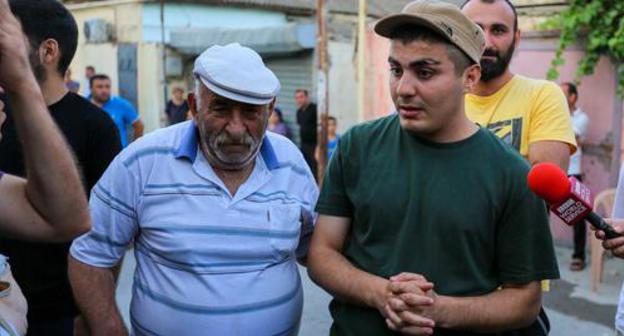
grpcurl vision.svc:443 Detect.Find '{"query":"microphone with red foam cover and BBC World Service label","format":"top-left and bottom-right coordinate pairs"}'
top-left (527, 162), bottom-right (622, 239)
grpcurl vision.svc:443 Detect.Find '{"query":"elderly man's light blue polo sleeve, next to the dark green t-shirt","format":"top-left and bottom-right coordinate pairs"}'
top-left (296, 163), bottom-right (319, 259)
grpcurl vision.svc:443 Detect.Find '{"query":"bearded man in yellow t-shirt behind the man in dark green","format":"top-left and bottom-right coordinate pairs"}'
top-left (462, 0), bottom-right (576, 171)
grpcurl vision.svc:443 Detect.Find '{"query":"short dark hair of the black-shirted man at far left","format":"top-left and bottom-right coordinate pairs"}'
top-left (9, 0), bottom-right (78, 76)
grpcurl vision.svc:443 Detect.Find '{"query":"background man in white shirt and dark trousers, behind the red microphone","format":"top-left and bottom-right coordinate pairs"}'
top-left (561, 82), bottom-right (589, 271)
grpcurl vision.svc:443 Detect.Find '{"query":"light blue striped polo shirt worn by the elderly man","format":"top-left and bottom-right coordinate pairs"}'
top-left (71, 121), bottom-right (318, 335)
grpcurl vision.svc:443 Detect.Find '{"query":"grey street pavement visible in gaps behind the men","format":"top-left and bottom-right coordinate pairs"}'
top-left (117, 247), bottom-right (624, 336)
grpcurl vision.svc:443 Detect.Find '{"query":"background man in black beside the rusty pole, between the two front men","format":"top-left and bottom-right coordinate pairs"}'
top-left (295, 89), bottom-right (318, 178)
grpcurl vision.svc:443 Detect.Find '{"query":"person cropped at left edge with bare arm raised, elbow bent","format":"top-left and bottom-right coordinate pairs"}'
top-left (0, 0), bottom-right (90, 335)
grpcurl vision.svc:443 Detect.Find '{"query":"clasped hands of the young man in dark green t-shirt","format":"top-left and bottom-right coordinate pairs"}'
top-left (384, 273), bottom-right (437, 335)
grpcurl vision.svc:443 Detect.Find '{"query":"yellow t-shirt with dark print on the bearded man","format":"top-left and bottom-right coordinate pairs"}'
top-left (466, 75), bottom-right (576, 158)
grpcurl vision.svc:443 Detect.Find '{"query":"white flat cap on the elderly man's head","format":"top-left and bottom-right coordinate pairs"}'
top-left (193, 43), bottom-right (280, 105)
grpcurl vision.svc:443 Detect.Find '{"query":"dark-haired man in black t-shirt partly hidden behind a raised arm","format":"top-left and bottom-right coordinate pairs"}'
top-left (0, 0), bottom-right (121, 335)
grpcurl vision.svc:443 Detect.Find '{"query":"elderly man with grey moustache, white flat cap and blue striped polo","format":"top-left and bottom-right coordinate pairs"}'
top-left (69, 44), bottom-right (318, 335)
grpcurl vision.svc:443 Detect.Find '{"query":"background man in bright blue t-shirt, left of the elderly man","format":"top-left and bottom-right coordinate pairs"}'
top-left (90, 74), bottom-right (143, 148)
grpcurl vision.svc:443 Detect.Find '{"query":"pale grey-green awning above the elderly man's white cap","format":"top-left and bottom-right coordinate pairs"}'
top-left (168, 23), bottom-right (316, 55)
